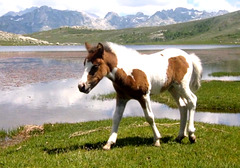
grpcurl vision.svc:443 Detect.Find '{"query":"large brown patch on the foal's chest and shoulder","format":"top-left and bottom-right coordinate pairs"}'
top-left (113, 69), bottom-right (149, 100)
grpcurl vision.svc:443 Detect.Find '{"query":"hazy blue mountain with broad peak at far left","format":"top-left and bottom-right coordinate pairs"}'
top-left (0, 6), bottom-right (97, 34)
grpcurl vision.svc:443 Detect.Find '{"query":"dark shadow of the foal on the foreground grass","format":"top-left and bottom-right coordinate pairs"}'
top-left (43, 136), bottom-right (175, 155)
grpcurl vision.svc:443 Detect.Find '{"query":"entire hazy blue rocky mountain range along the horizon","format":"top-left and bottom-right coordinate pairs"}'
top-left (0, 6), bottom-right (228, 34)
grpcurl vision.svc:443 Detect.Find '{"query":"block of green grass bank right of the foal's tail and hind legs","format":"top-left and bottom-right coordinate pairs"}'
top-left (197, 81), bottom-right (240, 112)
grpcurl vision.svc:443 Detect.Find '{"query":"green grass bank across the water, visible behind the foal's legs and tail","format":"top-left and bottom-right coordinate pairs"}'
top-left (94, 81), bottom-right (240, 112)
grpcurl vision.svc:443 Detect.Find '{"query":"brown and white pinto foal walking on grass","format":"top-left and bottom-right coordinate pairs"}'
top-left (78, 42), bottom-right (202, 150)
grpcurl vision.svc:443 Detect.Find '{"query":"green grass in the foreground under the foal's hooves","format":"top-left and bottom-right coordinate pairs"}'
top-left (0, 117), bottom-right (240, 168)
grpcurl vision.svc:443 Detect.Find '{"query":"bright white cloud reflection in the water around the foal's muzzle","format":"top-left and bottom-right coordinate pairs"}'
top-left (0, 79), bottom-right (113, 109)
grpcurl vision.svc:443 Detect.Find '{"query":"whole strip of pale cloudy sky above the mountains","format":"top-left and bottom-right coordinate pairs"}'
top-left (0, 0), bottom-right (240, 17)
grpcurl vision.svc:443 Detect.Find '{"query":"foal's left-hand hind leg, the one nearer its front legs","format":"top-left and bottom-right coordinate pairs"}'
top-left (168, 87), bottom-right (187, 142)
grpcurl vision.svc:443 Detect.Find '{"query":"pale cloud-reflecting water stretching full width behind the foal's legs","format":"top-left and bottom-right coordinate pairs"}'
top-left (0, 79), bottom-right (240, 129)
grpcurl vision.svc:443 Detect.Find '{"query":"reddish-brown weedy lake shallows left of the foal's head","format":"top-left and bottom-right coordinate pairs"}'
top-left (0, 52), bottom-right (86, 90)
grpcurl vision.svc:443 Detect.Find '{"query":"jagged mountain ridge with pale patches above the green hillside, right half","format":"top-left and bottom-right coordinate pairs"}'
top-left (101, 8), bottom-right (228, 29)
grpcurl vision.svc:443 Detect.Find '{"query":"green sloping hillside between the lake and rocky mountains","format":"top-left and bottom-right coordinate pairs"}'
top-left (27, 11), bottom-right (240, 44)
